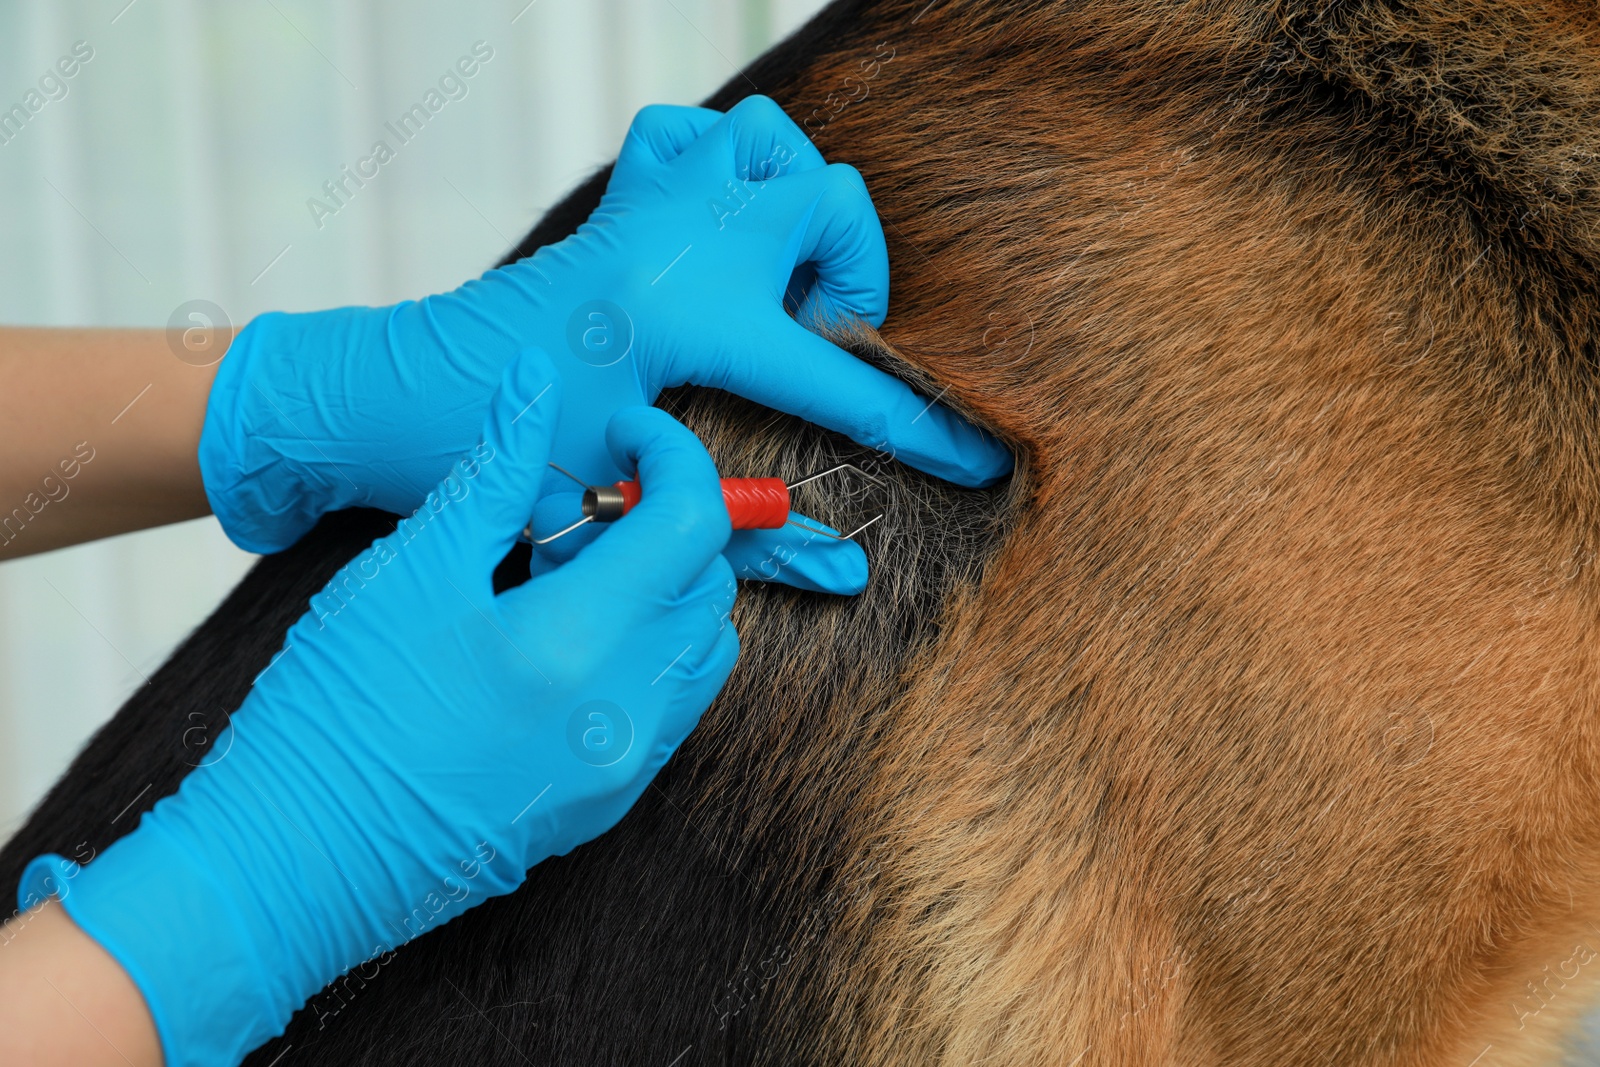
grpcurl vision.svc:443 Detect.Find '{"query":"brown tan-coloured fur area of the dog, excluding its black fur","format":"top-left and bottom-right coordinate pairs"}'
top-left (694, 0), bottom-right (1600, 1067)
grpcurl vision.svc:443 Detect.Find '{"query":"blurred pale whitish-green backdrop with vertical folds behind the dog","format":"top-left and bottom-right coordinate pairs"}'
top-left (0, 0), bottom-right (824, 840)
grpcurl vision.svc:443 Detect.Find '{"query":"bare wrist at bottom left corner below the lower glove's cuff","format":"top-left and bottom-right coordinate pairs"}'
top-left (0, 901), bottom-right (162, 1067)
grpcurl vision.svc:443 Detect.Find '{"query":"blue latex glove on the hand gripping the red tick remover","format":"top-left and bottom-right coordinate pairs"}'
top-left (19, 347), bottom-right (739, 1067)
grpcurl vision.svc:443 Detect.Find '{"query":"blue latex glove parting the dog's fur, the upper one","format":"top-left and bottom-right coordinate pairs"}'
top-left (200, 96), bottom-right (1011, 592)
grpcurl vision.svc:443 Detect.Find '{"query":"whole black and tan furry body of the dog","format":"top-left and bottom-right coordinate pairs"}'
top-left (0, 0), bottom-right (1600, 1067)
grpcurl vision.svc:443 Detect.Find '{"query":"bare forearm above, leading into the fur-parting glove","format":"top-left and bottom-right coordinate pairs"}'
top-left (0, 326), bottom-right (232, 561)
